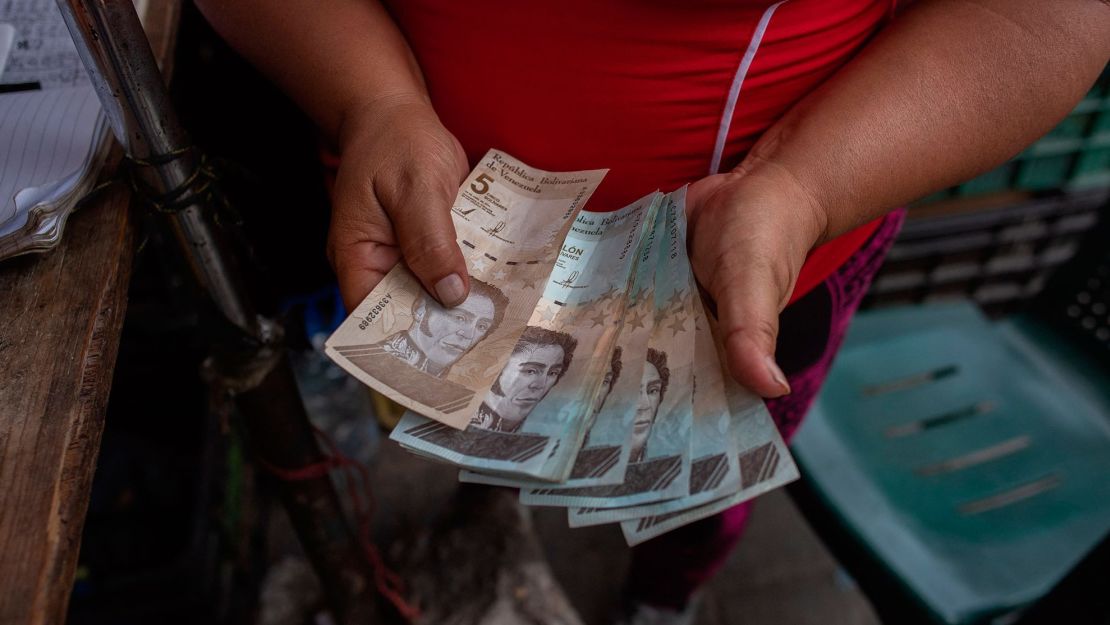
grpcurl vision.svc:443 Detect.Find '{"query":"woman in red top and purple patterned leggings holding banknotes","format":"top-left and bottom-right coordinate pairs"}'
top-left (198, 0), bottom-right (1110, 616)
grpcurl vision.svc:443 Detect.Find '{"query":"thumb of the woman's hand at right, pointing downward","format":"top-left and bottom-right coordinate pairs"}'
top-left (710, 249), bottom-right (794, 397)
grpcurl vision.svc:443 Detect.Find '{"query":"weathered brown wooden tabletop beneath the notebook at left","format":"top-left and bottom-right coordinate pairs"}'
top-left (0, 1), bottom-right (180, 625)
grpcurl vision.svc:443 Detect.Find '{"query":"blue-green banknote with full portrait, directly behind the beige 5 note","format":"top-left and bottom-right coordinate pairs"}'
top-left (391, 194), bottom-right (658, 482)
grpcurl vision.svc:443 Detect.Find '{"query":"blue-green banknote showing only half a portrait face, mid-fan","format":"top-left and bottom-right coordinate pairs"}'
top-left (521, 188), bottom-right (697, 507)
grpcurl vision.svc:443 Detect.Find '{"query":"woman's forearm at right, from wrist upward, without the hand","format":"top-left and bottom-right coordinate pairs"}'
top-left (737, 0), bottom-right (1110, 243)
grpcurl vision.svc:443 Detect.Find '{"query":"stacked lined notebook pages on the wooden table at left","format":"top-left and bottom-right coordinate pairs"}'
top-left (0, 0), bottom-right (140, 259)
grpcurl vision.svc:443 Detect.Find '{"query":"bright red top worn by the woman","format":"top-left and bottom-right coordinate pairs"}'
top-left (385, 0), bottom-right (892, 301)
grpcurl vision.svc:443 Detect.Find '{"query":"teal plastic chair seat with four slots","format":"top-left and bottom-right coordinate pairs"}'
top-left (794, 303), bottom-right (1110, 625)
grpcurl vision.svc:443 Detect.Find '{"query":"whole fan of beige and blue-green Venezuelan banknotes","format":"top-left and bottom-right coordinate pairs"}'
top-left (326, 150), bottom-right (797, 544)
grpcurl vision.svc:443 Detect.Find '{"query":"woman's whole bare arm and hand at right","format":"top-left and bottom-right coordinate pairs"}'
top-left (689, 0), bottom-right (1110, 396)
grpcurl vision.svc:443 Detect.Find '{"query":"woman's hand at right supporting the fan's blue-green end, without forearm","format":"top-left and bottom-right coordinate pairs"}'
top-left (687, 164), bottom-right (826, 397)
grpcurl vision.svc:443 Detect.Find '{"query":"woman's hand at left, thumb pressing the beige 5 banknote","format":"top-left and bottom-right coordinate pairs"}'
top-left (327, 98), bottom-right (470, 311)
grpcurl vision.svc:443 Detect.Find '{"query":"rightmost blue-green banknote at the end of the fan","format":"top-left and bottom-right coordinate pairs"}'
top-left (620, 319), bottom-right (798, 545)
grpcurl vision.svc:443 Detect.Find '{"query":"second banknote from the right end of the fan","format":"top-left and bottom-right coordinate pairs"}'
top-left (555, 301), bottom-right (746, 525)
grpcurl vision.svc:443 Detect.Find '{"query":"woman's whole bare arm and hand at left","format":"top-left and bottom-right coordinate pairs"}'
top-left (196, 0), bottom-right (470, 310)
